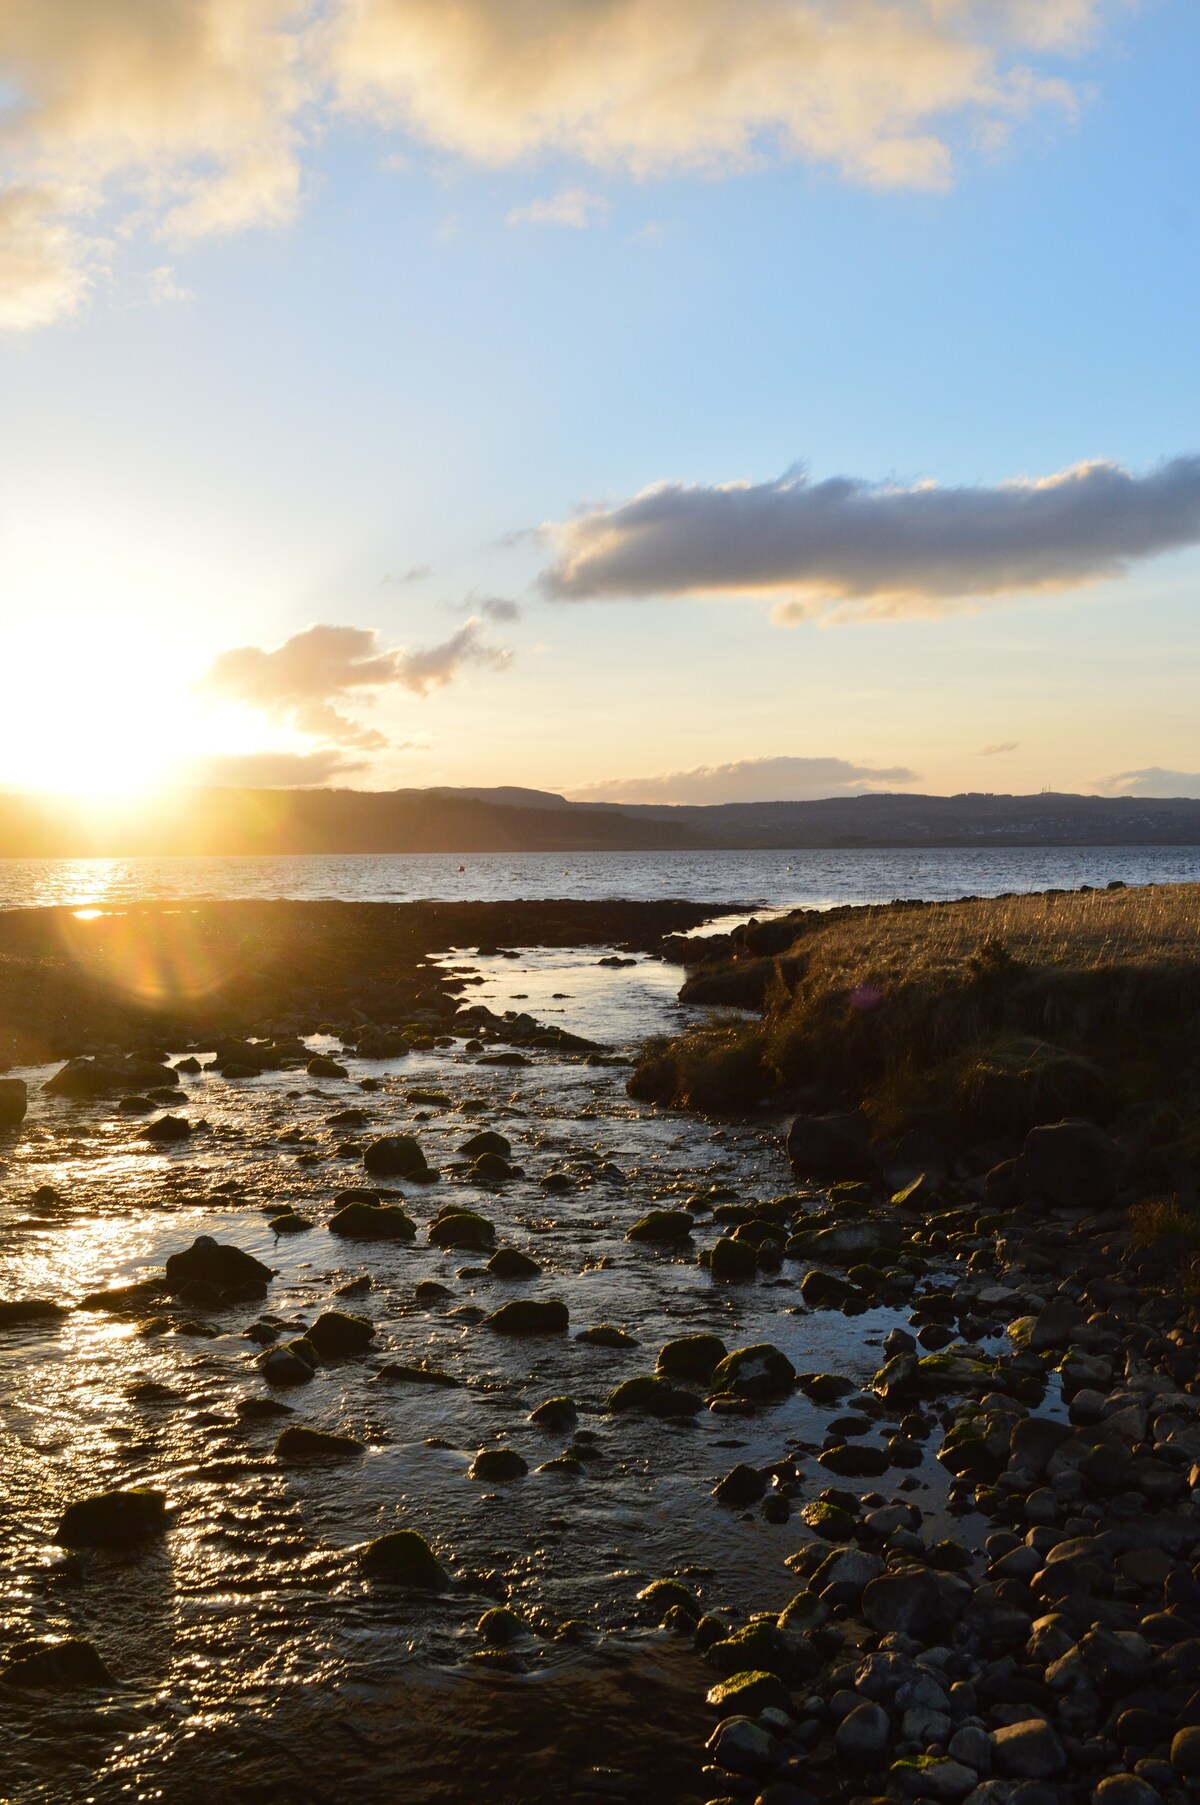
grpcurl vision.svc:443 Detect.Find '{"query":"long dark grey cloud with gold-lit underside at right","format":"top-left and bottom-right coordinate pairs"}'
top-left (541, 457), bottom-right (1200, 625)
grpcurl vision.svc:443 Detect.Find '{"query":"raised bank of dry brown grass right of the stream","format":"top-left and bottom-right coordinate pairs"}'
top-left (632, 884), bottom-right (1200, 1153)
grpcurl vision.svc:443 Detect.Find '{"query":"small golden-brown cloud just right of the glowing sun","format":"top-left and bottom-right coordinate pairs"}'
top-left (195, 616), bottom-right (512, 736)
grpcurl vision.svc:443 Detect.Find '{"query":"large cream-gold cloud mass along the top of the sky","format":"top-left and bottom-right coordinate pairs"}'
top-left (0, 0), bottom-right (1112, 327)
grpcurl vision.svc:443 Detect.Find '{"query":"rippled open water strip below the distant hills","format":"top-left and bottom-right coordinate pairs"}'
top-left (0, 847), bottom-right (1200, 908)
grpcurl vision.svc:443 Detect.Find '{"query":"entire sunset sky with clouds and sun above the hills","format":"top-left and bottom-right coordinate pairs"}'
top-left (0, 0), bottom-right (1200, 801)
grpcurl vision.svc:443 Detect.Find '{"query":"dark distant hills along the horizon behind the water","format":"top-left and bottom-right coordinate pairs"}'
top-left (0, 787), bottom-right (1200, 857)
